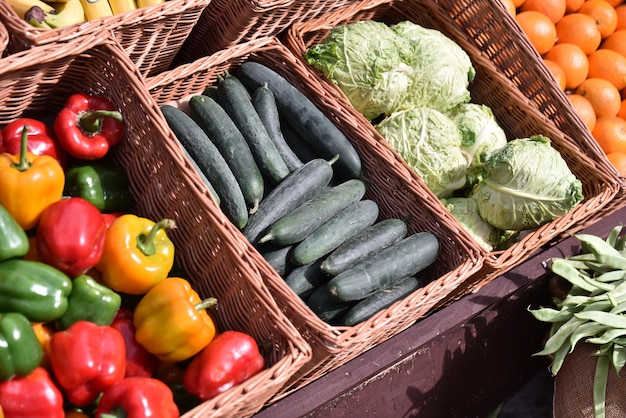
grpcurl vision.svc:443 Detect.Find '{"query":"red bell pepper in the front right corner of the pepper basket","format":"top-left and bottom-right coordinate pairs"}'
top-left (183, 331), bottom-right (265, 401)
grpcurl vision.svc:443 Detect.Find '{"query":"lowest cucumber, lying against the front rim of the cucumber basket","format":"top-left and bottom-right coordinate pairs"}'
top-left (339, 276), bottom-right (424, 327)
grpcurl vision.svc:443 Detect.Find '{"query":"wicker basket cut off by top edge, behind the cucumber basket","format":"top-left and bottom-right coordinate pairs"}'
top-left (177, 0), bottom-right (364, 63)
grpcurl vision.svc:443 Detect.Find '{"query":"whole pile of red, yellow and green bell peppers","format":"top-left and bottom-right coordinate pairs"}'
top-left (0, 93), bottom-right (265, 418)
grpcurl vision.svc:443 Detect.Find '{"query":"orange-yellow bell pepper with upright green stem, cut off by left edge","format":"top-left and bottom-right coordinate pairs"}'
top-left (0, 128), bottom-right (65, 230)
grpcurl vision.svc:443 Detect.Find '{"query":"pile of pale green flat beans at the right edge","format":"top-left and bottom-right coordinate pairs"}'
top-left (528, 225), bottom-right (626, 418)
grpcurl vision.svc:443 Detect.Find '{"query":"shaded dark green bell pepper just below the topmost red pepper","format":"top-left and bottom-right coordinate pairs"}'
top-left (63, 161), bottom-right (132, 213)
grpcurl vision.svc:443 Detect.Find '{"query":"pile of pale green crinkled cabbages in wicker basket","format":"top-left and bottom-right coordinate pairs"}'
top-left (305, 20), bottom-right (583, 251)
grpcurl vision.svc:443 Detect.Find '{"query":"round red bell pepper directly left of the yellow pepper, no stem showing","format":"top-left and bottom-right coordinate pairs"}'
top-left (36, 197), bottom-right (107, 277)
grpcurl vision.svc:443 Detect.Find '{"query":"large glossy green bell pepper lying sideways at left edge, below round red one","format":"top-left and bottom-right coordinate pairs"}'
top-left (0, 258), bottom-right (72, 322)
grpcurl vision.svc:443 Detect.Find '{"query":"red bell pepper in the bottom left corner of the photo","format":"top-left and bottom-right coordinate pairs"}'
top-left (0, 367), bottom-right (65, 418)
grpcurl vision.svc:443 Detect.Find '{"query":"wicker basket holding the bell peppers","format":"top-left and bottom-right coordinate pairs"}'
top-left (0, 33), bottom-right (311, 418)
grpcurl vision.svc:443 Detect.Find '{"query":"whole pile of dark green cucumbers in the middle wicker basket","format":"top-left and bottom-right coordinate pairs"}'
top-left (161, 61), bottom-right (440, 326)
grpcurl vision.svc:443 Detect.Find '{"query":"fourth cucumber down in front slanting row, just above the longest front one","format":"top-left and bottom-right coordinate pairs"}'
top-left (320, 219), bottom-right (407, 276)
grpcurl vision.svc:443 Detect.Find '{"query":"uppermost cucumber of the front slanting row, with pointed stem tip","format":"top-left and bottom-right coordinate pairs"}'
top-left (242, 158), bottom-right (334, 245)
